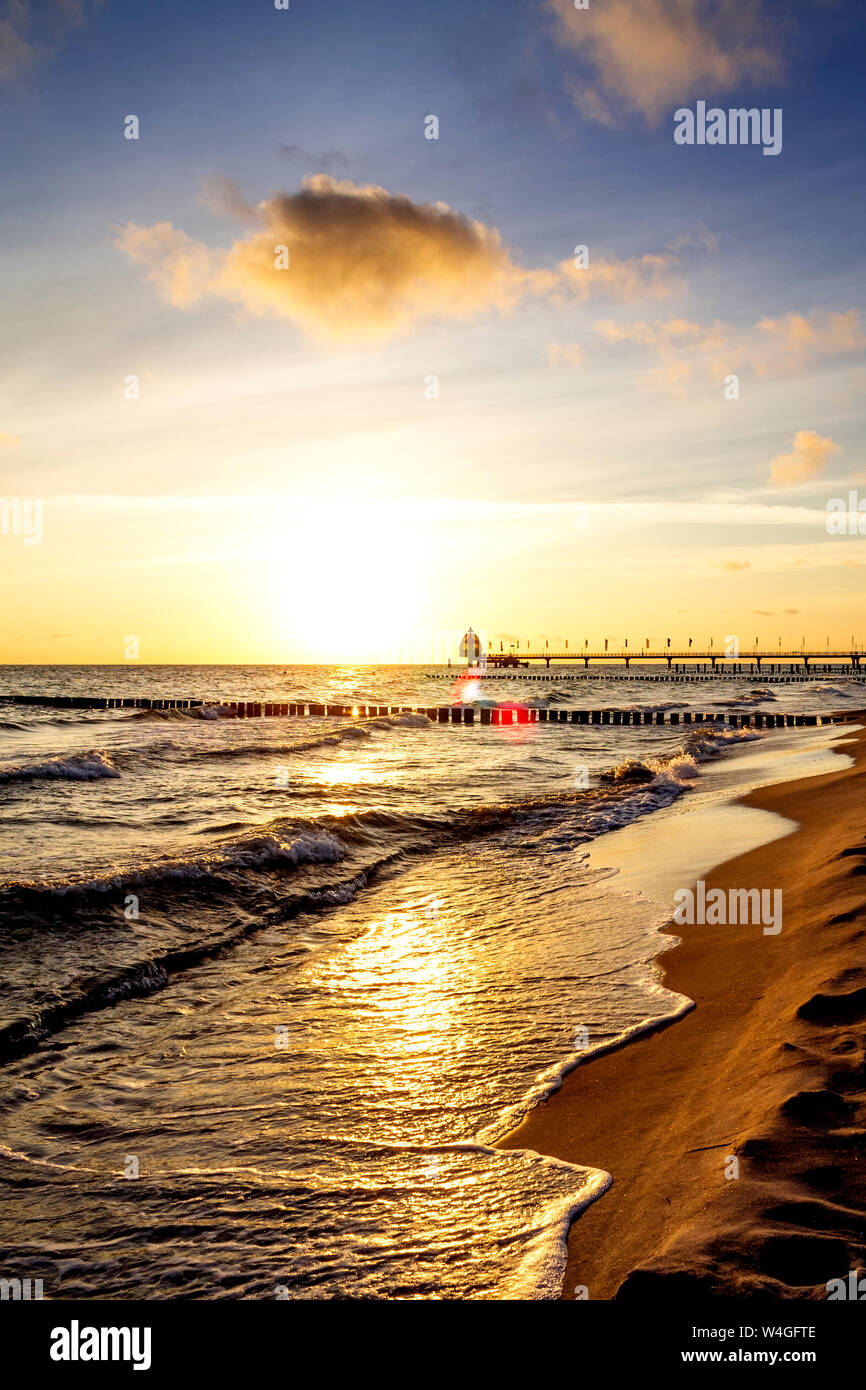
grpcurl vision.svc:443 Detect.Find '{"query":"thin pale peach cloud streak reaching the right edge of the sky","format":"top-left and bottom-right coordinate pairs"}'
top-left (595, 309), bottom-right (866, 393)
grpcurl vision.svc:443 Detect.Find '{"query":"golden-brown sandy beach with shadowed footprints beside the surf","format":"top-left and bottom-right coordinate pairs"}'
top-left (502, 730), bottom-right (866, 1300)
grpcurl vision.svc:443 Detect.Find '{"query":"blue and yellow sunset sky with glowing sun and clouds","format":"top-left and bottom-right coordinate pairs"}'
top-left (0, 0), bottom-right (866, 663)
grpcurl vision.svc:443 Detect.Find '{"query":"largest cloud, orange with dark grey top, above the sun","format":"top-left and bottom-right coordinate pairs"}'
top-left (115, 174), bottom-right (678, 342)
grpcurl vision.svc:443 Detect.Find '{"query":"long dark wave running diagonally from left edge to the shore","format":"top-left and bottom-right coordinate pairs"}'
top-left (0, 727), bottom-right (760, 1058)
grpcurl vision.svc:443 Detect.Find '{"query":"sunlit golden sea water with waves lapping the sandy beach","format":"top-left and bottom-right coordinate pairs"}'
top-left (0, 667), bottom-right (863, 1298)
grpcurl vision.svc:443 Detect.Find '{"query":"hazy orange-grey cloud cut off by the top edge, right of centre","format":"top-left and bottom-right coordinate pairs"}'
top-left (549, 0), bottom-right (784, 125)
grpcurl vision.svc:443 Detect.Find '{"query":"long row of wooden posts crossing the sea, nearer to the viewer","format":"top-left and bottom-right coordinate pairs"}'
top-left (0, 695), bottom-right (859, 728)
